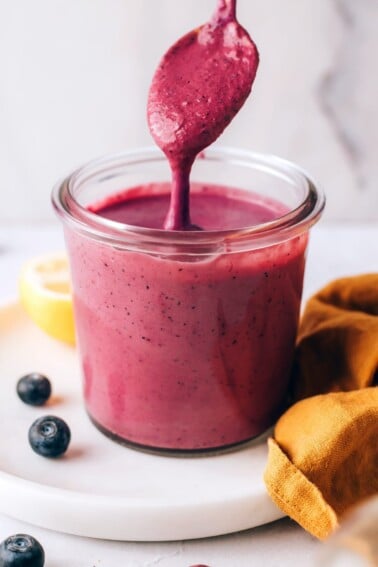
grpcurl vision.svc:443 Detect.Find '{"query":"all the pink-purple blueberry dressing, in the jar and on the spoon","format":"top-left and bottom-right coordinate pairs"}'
top-left (65, 0), bottom-right (307, 451)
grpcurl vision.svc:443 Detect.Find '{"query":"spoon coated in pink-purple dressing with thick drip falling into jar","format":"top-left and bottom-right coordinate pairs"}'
top-left (147, 0), bottom-right (259, 230)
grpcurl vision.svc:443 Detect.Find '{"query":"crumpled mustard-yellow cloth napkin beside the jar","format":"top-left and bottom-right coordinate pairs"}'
top-left (264, 274), bottom-right (378, 539)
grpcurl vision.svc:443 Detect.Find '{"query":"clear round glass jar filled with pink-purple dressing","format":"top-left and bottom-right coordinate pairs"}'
top-left (53, 148), bottom-right (324, 453)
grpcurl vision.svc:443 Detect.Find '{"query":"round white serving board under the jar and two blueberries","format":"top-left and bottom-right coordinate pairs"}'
top-left (0, 302), bottom-right (283, 541)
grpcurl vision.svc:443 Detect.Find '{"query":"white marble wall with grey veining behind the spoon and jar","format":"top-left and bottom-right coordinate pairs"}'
top-left (0, 0), bottom-right (378, 223)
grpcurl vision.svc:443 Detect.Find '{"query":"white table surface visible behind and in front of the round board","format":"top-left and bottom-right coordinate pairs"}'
top-left (0, 223), bottom-right (378, 567)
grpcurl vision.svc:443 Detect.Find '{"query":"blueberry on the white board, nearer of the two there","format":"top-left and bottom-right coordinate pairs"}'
top-left (28, 415), bottom-right (71, 460)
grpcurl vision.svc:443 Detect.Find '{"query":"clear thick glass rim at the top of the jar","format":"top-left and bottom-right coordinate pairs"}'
top-left (51, 146), bottom-right (325, 250)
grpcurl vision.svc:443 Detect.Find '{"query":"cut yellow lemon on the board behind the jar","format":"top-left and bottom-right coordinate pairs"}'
top-left (19, 253), bottom-right (75, 345)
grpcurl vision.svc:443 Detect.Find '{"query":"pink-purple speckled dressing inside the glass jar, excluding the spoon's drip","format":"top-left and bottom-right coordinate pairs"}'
top-left (66, 190), bottom-right (307, 451)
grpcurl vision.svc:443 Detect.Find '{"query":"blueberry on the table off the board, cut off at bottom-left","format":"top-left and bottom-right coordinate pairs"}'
top-left (0, 534), bottom-right (45, 567)
